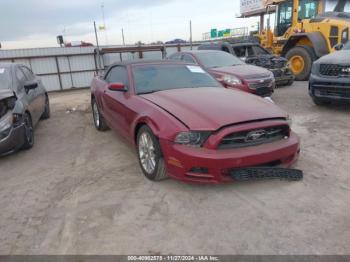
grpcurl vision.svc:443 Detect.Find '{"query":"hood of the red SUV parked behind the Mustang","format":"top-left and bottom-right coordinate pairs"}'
top-left (209, 65), bottom-right (271, 79)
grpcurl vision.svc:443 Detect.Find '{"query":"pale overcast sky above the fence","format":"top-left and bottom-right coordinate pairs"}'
top-left (0, 0), bottom-right (257, 49)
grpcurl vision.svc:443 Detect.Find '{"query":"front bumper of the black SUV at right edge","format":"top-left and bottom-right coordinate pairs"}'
top-left (309, 74), bottom-right (350, 102)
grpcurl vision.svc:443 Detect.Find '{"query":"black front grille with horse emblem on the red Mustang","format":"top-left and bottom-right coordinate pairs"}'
top-left (219, 125), bottom-right (290, 149)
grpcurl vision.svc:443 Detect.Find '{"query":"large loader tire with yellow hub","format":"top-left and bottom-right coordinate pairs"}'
top-left (286, 46), bottom-right (317, 81)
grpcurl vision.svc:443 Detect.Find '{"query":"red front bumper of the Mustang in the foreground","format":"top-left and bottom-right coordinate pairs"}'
top-left (160, 132), bottom-right (300, 183)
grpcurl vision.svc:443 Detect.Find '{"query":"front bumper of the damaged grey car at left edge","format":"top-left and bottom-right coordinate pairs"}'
top-left (0, 124), bottom-right (25, 156)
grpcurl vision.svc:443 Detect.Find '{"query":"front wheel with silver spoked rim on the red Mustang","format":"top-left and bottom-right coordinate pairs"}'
top-left (137, 125), bottom-right (168, 181)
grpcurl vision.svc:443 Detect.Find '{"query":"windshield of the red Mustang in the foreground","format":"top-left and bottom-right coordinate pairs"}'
top-left (133, 64), bottom-right (221, 94)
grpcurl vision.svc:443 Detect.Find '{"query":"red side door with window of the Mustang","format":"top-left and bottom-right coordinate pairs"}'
top-left (102, 66), bottom-right (130, 137)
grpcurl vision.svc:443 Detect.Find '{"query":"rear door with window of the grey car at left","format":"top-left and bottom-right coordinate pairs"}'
top-left (21, 66), bottom-right (46, 120)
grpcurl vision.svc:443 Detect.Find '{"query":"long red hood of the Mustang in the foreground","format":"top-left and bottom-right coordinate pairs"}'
top-left (141, 87), bottom-right (287, 131)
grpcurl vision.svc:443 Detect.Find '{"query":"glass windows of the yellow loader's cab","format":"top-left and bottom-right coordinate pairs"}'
top-left (275, 0), bottom-right (319, 37)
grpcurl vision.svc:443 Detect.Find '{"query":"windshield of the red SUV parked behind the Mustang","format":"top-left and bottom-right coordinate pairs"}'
top-left (196, 52), bottom-right (244, 68)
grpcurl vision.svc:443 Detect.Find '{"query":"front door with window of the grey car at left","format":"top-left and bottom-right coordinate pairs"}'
top-left (15, 66), bottom-right (38, 124)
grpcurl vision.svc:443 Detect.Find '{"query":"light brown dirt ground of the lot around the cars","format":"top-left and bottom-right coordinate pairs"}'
top-left (0, 82), bottom-right (350, 255)
